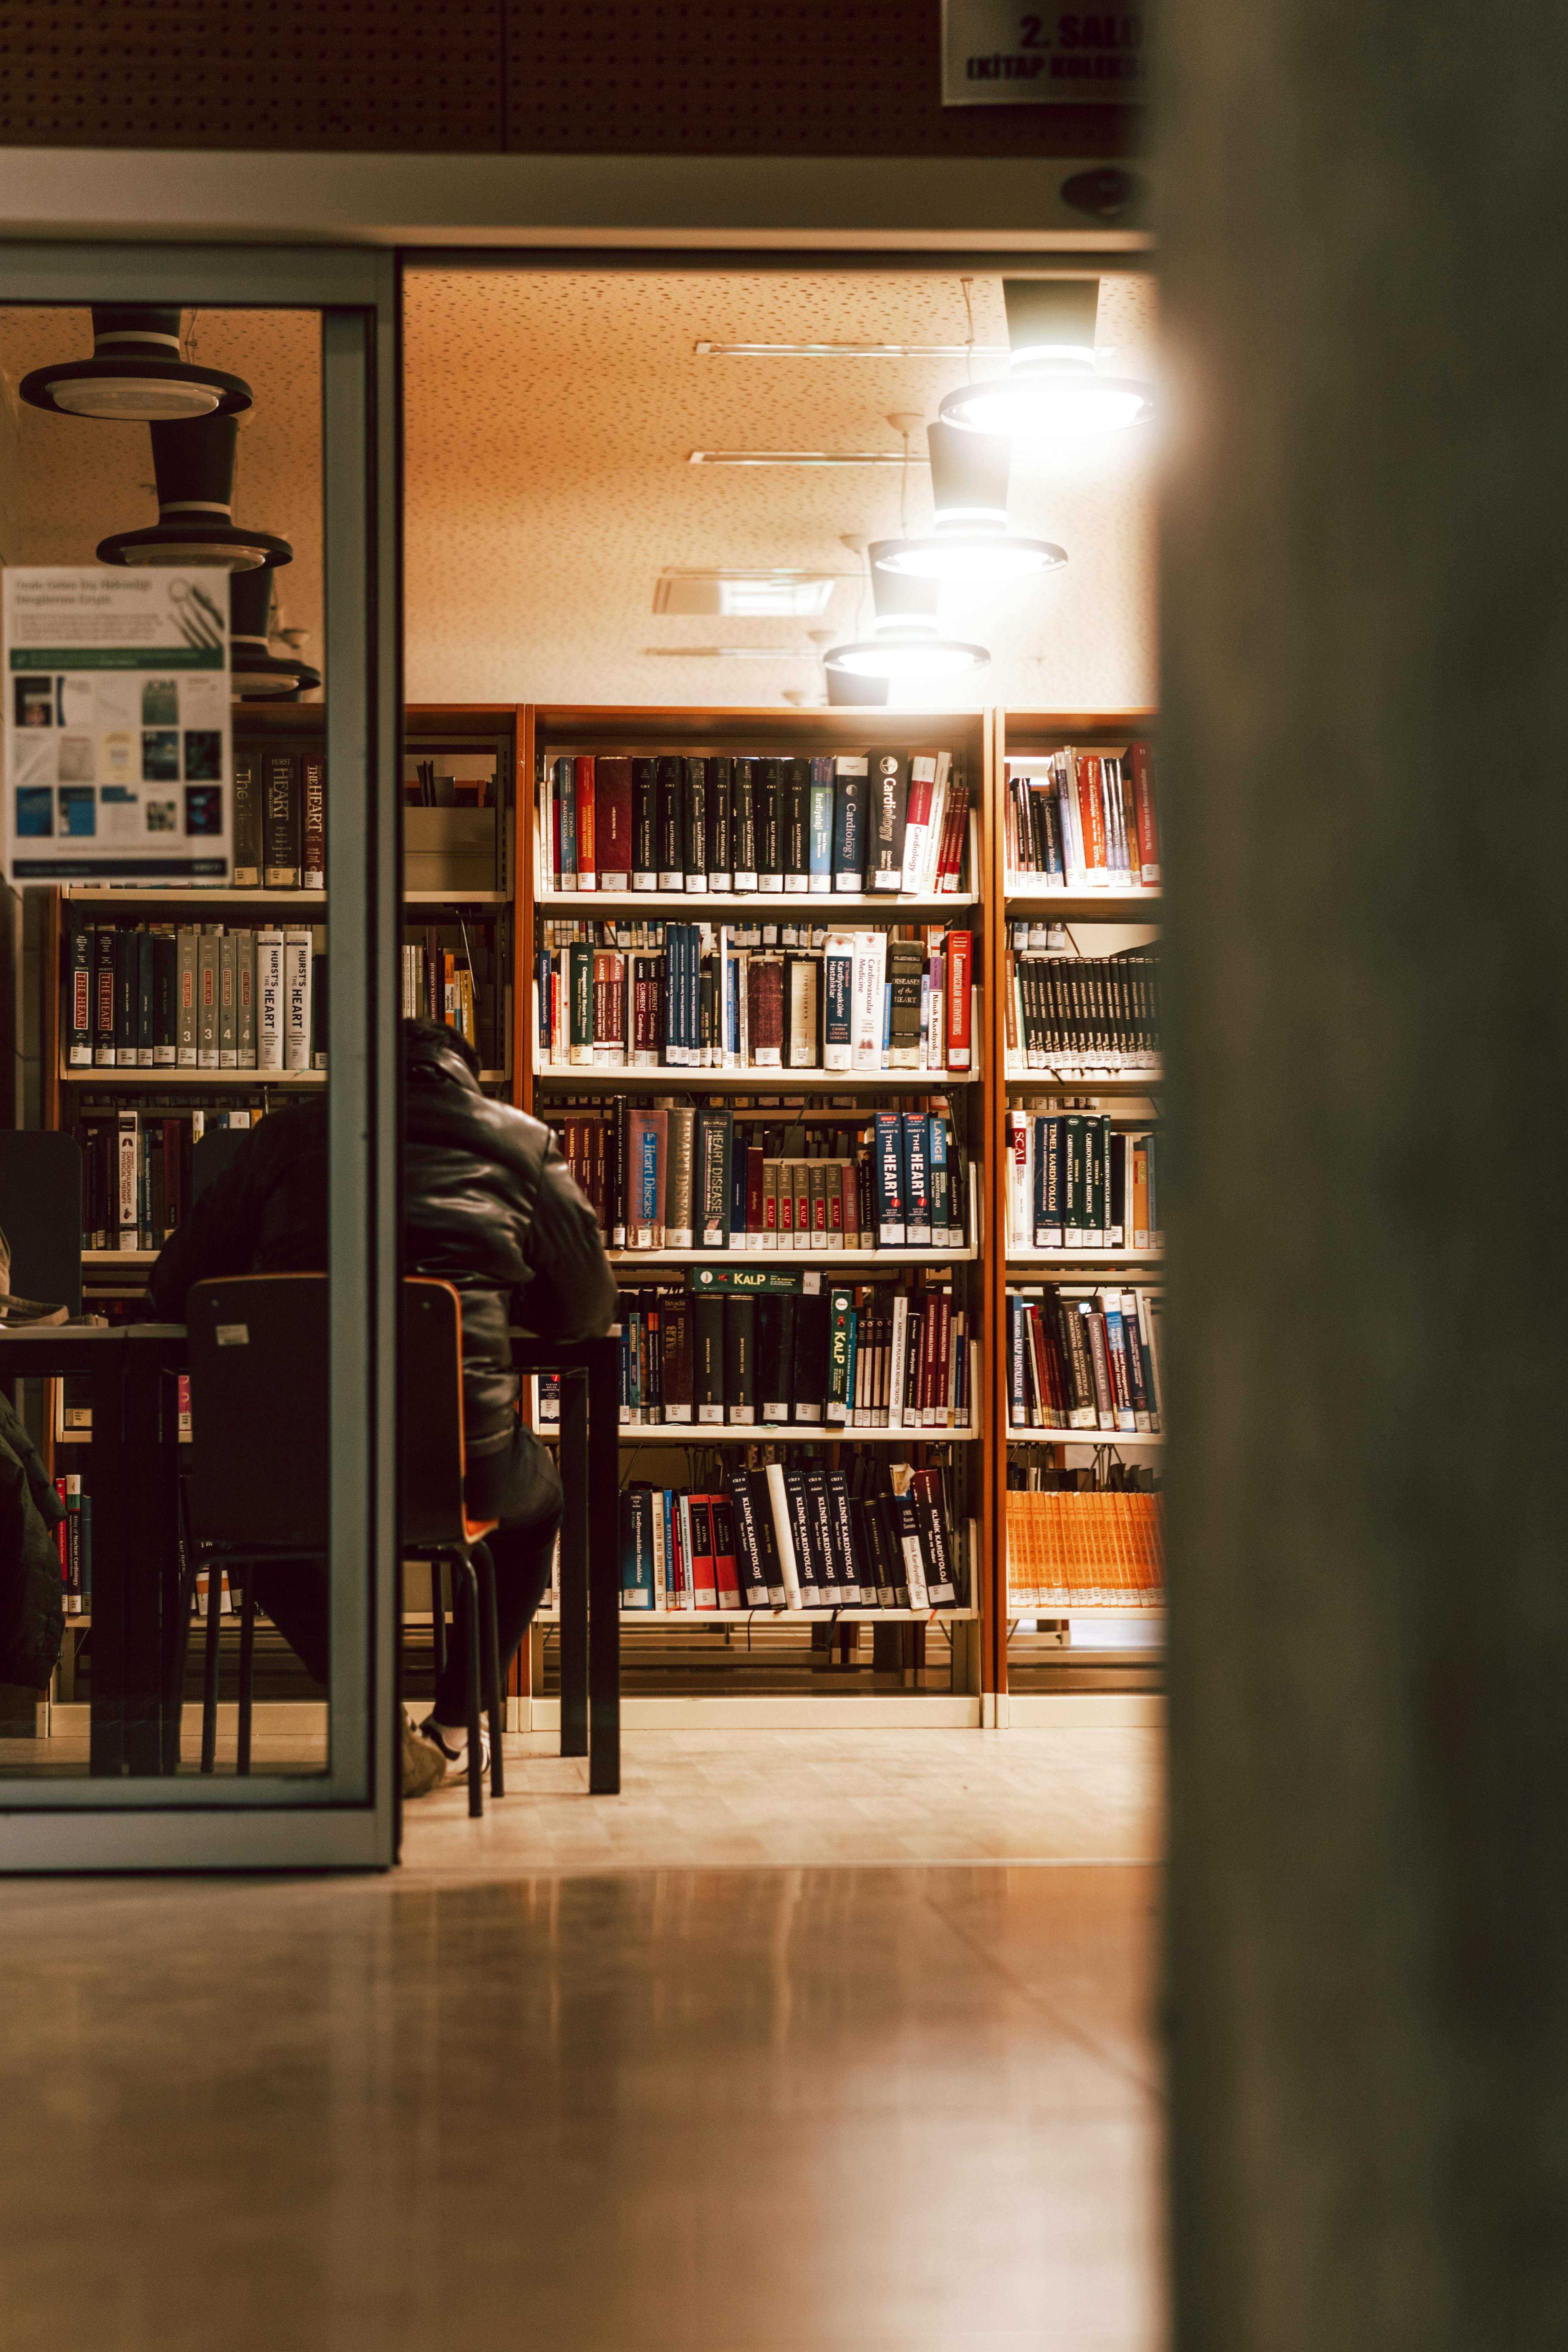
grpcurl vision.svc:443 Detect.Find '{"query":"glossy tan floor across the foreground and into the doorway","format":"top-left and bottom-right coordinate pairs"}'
top-left (0, 1733), bottom-right (1159, 2352)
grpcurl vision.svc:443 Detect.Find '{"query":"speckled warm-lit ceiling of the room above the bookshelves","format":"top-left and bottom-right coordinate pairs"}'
top-left (0, 270), bottom-right (1157, 708)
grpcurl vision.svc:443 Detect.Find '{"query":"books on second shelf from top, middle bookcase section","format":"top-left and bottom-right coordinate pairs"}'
top-left (536, 922), bottom-right (975, 1073)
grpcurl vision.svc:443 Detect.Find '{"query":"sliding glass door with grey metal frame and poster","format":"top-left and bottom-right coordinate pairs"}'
top-left (0, 247), bottom-right (402, 1870)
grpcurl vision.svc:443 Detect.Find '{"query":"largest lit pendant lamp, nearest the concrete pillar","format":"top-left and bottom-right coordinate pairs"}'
top-left (940, 278), bottom-right (1154, 454)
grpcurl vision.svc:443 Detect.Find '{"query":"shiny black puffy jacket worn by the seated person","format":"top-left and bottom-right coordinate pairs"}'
top-left (148, 1033), bottom-right (616, 1453)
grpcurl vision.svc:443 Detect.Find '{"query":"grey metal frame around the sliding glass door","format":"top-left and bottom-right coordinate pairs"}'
top-left (0, 242), bottom-right (402, 1872)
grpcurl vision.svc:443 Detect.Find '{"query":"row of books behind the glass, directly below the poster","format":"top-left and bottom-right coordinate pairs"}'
top-left (66, 908), bottom-right (327, 1070)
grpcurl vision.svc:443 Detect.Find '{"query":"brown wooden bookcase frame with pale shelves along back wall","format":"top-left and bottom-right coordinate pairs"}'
top-left (40, 703), bottom-right (1161, 1726)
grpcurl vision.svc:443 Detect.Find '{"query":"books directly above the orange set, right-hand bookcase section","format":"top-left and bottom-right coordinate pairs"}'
top-left (1006, 1284), bottom-right (1166, 1437)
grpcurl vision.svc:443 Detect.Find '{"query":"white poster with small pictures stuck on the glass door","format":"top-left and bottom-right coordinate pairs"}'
top-left (5, 564), bottom-right (233, 884)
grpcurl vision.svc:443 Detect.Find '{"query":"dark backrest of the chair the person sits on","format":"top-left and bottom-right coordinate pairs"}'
top-left (186, 1275), bottom-right (463, 1553)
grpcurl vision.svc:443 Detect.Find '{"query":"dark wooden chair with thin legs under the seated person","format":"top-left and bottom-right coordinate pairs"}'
top-left (186, 1275), bottom-right (505, 1816)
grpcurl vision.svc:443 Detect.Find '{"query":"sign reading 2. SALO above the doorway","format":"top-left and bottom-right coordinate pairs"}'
top-left (943, 0), bottom-right (1149, 106)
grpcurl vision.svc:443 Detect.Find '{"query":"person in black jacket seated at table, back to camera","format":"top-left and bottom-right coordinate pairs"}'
top-left (148, 1021), bottom-right (616, 1797)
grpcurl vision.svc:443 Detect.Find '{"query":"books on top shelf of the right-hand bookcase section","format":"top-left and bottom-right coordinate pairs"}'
top-left (1004, 743), bottom-right (1159, 889)
